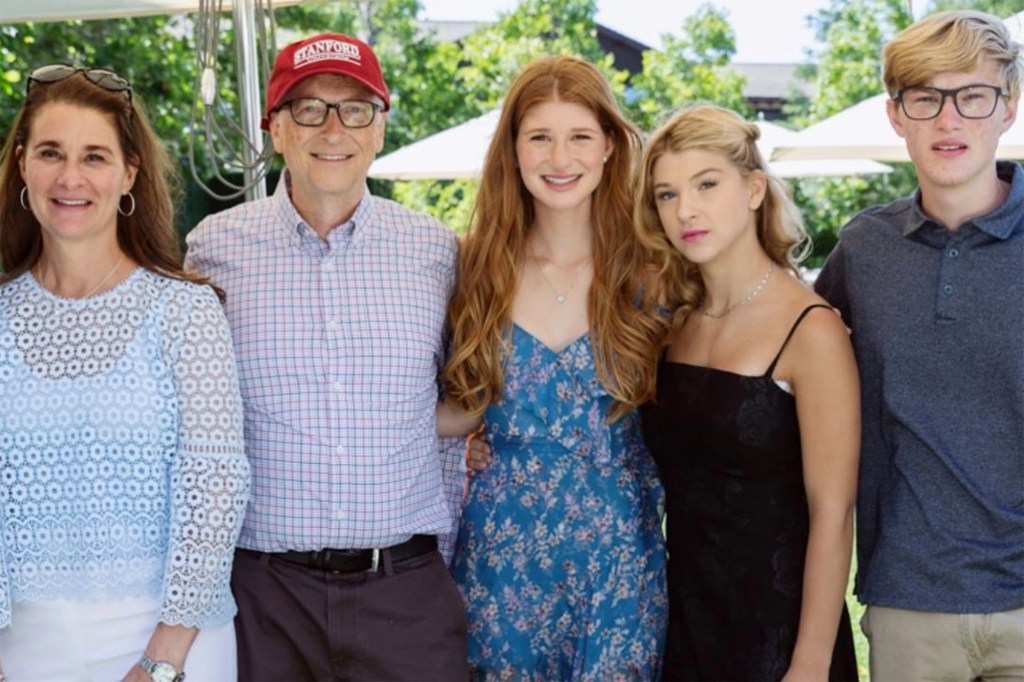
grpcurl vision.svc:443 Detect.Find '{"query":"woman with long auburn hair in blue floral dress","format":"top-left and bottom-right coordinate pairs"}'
top-left (445, 56), bottom-right (667, 680)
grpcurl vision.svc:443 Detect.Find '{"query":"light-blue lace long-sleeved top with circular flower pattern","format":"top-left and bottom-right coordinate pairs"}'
top-left (0, 268), bottom-right (249, 628)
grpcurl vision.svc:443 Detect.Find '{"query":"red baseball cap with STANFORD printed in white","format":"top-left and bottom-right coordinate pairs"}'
top-left (260, 33), bottom-right (391, 130)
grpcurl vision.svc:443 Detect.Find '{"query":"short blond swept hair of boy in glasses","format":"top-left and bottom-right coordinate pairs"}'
top-left (883, 9), bottom-right (1021, 99)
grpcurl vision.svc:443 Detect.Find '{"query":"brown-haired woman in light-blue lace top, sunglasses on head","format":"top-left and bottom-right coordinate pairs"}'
top-left (0, 65), bottom-right (249, 682)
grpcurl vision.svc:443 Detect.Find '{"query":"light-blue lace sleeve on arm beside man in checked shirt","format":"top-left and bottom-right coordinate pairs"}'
top-left (161, 287), bottom-right (249, 628)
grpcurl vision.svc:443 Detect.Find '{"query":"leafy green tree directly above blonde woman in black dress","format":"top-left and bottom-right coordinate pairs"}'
top-left (627, 3), bottom-right (752, 132)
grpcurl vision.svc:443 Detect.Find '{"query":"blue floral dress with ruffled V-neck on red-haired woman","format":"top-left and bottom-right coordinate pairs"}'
top-left (453, 326), bottom-right (668, 681)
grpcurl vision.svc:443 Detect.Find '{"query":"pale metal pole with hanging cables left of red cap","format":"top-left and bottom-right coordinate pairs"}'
top-left (231, 0), bottom-right (266, 201)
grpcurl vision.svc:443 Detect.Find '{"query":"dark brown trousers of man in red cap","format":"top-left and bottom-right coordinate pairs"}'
top-left (231, 550), bottom-right (469, 682)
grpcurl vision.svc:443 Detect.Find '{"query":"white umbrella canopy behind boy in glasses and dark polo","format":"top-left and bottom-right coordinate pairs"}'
top-left (772, 12), bottom-right (1024, 163)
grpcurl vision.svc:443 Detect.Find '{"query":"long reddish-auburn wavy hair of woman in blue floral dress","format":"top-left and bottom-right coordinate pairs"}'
top-left (444, 56), bottom-right (655, 420)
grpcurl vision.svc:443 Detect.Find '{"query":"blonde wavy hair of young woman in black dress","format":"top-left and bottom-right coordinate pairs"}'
top-left (634, 103), bottom-right (810, 350)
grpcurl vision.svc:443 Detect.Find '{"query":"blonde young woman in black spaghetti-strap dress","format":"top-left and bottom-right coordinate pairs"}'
top-left (636, 105), bottom-right (860, 680)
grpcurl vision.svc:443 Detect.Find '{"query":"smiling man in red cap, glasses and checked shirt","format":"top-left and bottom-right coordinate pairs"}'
top-left (188, 34), bottom-right (468, 680)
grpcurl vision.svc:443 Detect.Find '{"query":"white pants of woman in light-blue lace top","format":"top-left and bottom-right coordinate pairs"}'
top-left (0, 597), bottom-right (238, 682)
